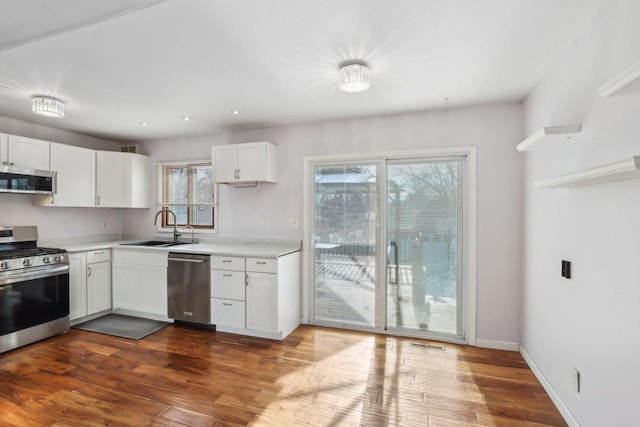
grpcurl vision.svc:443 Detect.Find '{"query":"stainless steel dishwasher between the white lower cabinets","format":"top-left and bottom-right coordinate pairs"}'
top-left (167, 252), bottom-right (213, 329)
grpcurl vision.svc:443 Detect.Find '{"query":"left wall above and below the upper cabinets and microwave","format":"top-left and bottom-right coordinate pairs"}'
top-left (0, 116), bottom-right (122, 240)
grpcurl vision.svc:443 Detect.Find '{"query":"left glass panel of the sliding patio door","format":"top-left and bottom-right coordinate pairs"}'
top-left (313, 164), bottom-right (378, 326)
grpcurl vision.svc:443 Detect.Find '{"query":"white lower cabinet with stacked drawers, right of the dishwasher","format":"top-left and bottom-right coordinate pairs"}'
top-left (211, 252), bottom-right (300, 339)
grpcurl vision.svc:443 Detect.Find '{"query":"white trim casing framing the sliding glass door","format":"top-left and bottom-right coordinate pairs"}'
top-left (301, 145), bottom-right (477, 345)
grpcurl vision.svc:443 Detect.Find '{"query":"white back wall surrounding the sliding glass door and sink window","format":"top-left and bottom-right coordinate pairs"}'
top-left (123, 104), bottom-right (523, 342)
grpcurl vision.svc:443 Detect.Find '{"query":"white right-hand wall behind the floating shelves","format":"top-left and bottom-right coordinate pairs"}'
top-left (521, 0), bottom-right (640, 427)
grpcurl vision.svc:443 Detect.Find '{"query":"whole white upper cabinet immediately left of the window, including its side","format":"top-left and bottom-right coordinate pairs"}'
top-left (96, 151), bottom-right (151, 208)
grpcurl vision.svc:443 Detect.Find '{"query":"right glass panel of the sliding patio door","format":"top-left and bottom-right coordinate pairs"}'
top-left (386, 160), bottom-right (462, 336)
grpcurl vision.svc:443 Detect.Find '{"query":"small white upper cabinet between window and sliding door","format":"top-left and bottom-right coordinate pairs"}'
top-left (211, 141), bottom-right (278, 184)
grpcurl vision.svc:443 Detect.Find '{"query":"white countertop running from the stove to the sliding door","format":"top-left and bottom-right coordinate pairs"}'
top-left (58, 238), bottom-right (301, 258)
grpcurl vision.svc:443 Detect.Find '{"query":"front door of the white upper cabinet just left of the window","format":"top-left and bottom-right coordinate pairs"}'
top-left (96, 151), bottom-right (130, 208)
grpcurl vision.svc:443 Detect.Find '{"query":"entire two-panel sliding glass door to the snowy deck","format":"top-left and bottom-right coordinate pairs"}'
top-left (307, 155), bottom-right (466, 340)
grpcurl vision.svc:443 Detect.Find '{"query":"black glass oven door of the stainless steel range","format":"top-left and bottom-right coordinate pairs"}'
top-left (0, 265), bottom-right (69, 339)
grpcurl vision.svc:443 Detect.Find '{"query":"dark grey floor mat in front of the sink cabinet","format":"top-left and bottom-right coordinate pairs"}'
top-left (74, 314), bottom-right (170, 340)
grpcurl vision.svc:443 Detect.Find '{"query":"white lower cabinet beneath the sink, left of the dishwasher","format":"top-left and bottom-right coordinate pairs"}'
top-left (113, 249), bottom-right (168, 318)
